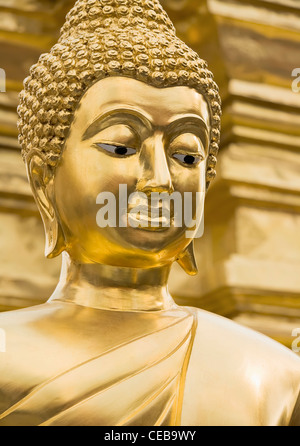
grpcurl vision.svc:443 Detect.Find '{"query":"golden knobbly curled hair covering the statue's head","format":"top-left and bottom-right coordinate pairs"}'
top-left (18, 0), bottom-right (221, 184)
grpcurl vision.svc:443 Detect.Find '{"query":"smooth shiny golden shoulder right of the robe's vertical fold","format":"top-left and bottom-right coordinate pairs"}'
top-left (180, 309), bottom-right (300, 425)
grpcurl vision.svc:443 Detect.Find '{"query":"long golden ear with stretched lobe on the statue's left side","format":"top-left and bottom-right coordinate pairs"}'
top-left (26, 151), bottom-right (65, 259)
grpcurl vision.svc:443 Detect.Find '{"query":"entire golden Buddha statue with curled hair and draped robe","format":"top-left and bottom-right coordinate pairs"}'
top-left (0, 0), bottom-right (300, 426)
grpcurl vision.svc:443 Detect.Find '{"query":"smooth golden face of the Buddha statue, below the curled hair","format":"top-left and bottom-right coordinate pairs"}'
top-left (54, 77), bottom-right (209, 267)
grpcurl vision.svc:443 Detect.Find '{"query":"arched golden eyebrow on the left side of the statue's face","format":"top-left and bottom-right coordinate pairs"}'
top-left (82, 109), bottom-right (151, 141)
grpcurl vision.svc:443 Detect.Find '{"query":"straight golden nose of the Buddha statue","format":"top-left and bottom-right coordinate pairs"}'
top-left (137, 133), bottom-right (174, 195)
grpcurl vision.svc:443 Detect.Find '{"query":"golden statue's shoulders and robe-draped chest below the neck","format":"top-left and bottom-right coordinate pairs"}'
top-left (0, 301), bottom-right (300, 426)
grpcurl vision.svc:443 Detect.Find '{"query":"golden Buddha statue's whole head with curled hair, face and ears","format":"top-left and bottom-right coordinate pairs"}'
top-left (18, 0), bottom-right (221, 273)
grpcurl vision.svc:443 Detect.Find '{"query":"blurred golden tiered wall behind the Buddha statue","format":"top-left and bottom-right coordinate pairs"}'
top-left (0, 0), bottom-right (300, 347)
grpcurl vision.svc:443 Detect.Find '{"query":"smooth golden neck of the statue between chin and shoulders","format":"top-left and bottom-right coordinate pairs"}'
top-left (49, 253), bottom-right (175, 311)
